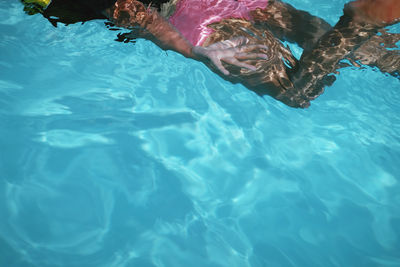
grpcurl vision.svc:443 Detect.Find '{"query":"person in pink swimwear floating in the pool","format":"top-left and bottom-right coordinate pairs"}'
top-left (22, 0), bottom-right (400, 108)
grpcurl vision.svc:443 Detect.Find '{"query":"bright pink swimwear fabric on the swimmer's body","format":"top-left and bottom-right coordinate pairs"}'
top-left (169, 0), bottom-right (268, 45)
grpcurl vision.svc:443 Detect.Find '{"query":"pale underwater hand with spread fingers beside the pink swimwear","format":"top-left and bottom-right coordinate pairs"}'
top-left (192, 37), bottom-right (268, 75)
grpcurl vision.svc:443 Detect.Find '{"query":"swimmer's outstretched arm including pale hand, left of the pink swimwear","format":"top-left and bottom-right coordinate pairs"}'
top-left (105, 0), bottom-right (266, 75)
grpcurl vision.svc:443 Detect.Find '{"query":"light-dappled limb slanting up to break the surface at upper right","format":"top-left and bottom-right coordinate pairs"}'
top-left (283, 0), bottom-right (400, 107)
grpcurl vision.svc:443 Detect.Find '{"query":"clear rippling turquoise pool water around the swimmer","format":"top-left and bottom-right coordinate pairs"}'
top-left (0, 0), bottom-right (400, 267)
